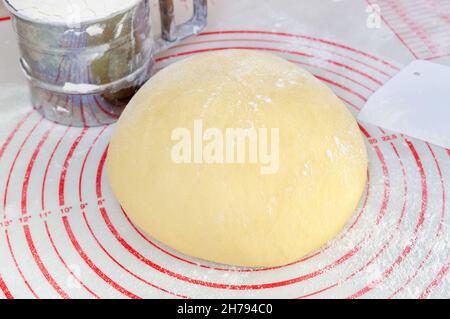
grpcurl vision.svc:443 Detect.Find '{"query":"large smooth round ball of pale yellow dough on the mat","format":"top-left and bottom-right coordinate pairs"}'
top-left (107, 50), bottom-right (367, 267)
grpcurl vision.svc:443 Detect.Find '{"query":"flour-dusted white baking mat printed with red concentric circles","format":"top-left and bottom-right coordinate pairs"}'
top-left (0, 0), bottom-right (450, 298)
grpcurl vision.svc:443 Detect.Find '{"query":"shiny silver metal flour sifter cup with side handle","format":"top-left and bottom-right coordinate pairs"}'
top-left (5, 0), bottom-right (206, 126)
